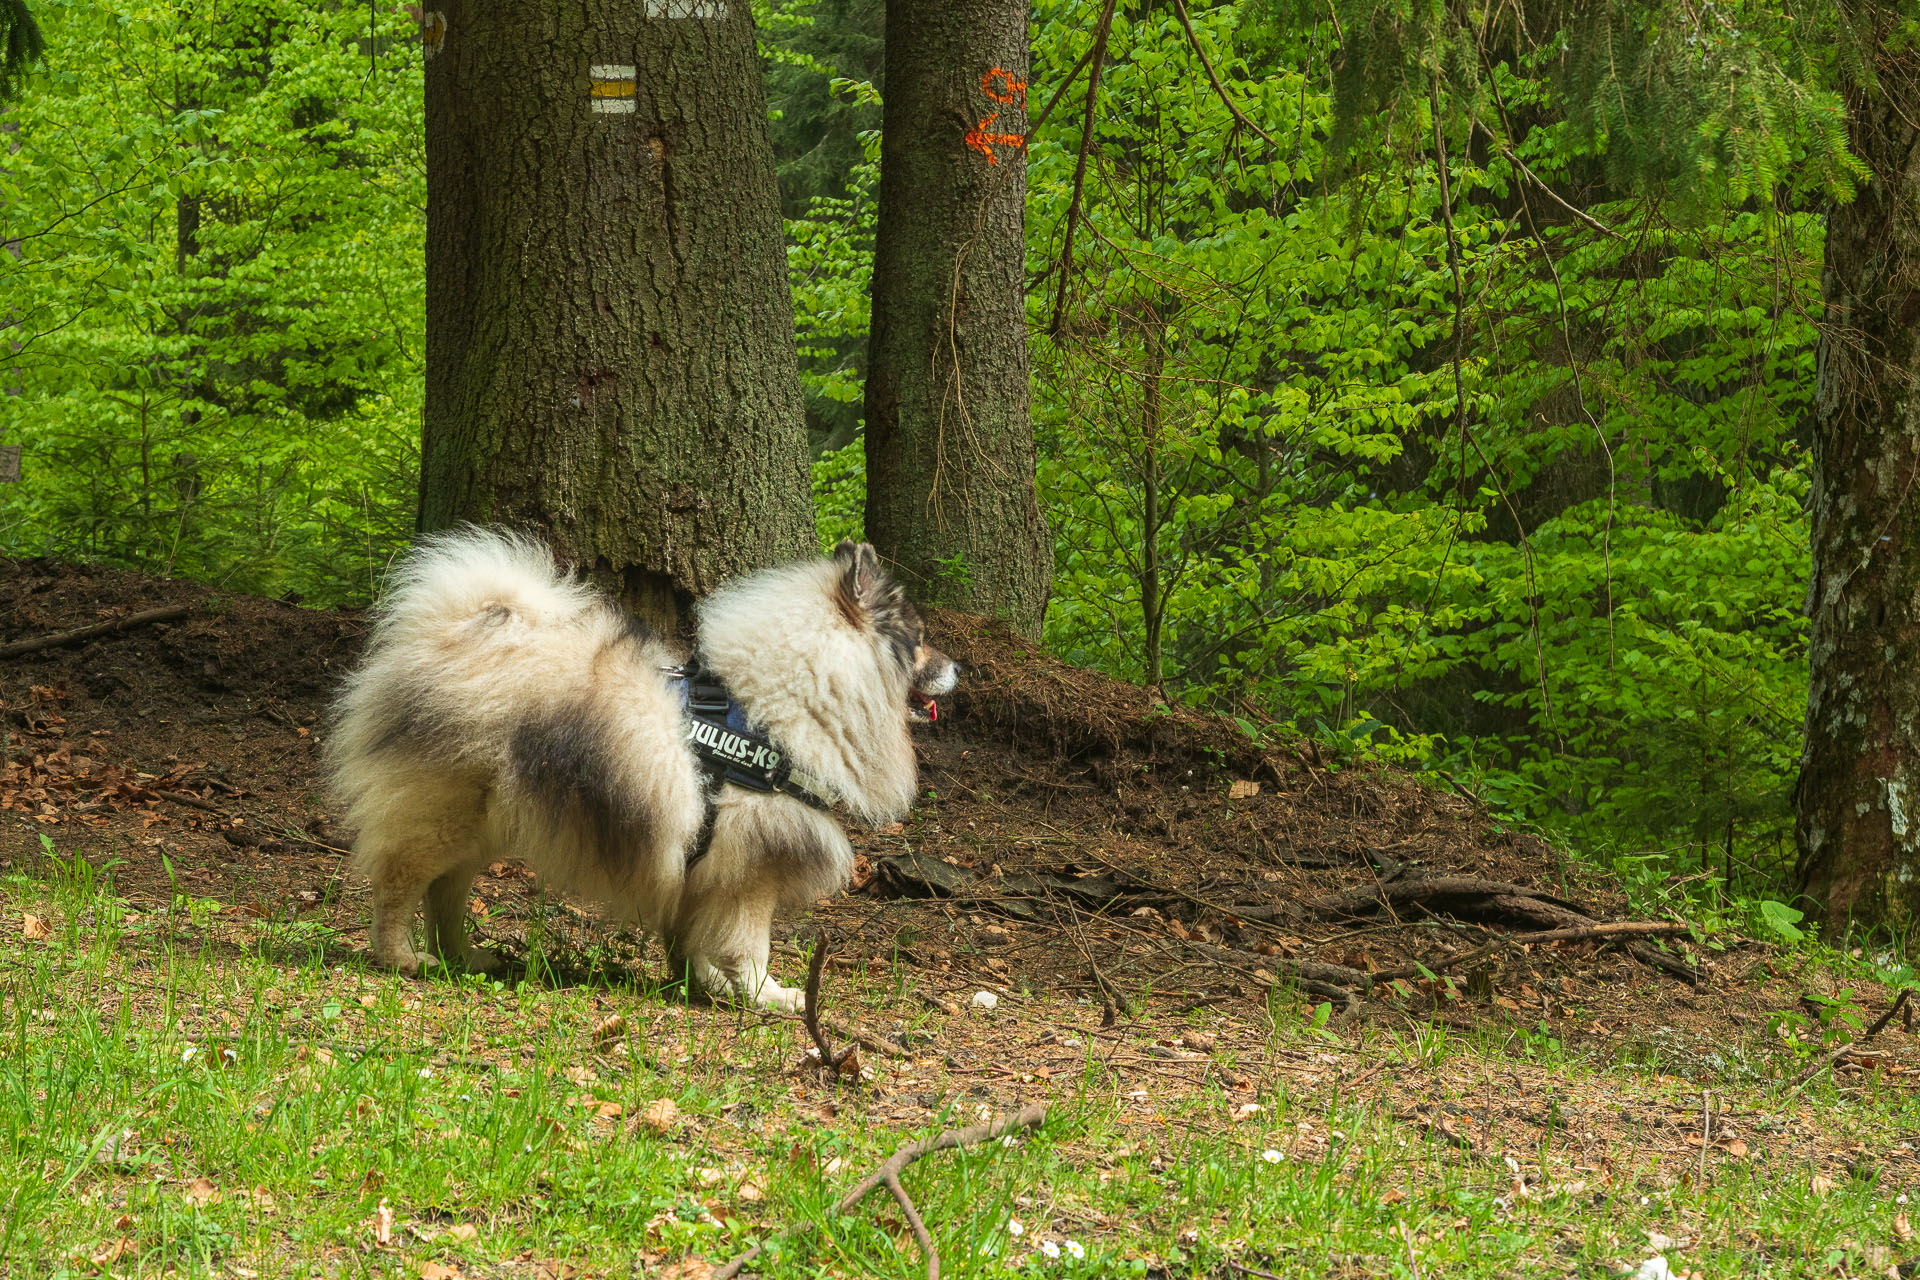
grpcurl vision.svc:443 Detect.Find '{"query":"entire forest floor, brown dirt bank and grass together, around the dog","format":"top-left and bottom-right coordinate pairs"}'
top-left (11, 560), bottom-right (1920, 1280)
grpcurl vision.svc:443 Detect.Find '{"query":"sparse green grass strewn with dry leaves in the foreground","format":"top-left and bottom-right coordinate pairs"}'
top-left (0, 860), bottom-right (1920, 1278)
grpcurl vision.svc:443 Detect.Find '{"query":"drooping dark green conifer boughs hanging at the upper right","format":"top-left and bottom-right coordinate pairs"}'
top-left (1273, 0), bottom-right (1864, 209)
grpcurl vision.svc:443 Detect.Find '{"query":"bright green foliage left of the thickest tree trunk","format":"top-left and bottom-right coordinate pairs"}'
top-left (0, 0), bottom-right (424, 601)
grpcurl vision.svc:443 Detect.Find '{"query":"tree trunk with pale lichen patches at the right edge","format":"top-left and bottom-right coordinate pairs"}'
top-left (1797, 6), bottom-right (1920, 935)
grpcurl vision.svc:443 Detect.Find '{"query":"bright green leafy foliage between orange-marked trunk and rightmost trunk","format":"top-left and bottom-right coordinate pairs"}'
top-left (1029, 4), bottom-right (1837, 887)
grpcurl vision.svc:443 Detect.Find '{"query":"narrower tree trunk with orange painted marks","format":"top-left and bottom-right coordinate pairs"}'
top-left (866, 0), bottom-right (1052, 635)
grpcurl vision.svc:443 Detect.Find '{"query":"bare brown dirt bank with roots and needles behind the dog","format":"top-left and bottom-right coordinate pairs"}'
top-left (0, 560), bottom-right (1910, 1075)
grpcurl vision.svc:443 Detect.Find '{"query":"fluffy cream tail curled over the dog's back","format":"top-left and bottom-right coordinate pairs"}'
top-left (372, 526), bottom-right (595, 649)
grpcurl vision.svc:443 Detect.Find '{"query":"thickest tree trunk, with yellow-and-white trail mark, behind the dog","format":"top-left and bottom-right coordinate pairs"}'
top-left (420, 0), bottom-right (814, 626)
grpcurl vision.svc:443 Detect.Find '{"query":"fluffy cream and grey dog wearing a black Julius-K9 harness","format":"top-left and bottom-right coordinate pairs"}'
top-left (328, 530), bottom-right (954, 1009)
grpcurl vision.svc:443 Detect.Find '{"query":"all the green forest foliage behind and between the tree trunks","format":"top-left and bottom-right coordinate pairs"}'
top-left (0, 0), bottom-right (1878, 901)
